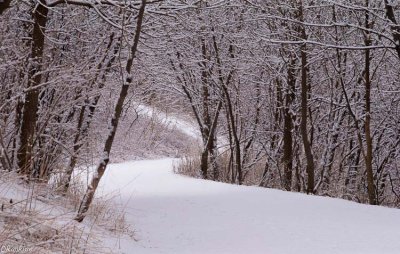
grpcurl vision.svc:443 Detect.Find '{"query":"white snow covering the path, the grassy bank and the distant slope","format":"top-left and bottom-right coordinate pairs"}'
top-left (0, 108), bottom-right (400, 254)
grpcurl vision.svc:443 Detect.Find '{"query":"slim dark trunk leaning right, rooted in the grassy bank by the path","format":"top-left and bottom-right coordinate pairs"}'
top-left (75, 0), bottom-right (146, 222)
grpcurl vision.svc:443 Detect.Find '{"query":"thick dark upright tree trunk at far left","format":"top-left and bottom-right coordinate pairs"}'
top-left (17, 0), bottom-right (48, 177)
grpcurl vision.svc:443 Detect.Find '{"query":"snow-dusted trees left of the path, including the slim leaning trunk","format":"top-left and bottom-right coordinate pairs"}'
top-left (0, 0), bottom-right (154, 221)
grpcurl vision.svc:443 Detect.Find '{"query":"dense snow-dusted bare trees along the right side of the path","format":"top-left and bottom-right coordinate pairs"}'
top-left (159, 0), bottom-right (400, 207)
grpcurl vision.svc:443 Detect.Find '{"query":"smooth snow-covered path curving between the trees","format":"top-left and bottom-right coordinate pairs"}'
top-left (97, 159), bottom-right (400, 254)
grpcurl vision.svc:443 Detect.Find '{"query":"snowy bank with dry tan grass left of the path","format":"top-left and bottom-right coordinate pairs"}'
top-left (0, 172), bottom-right (132, 253)
